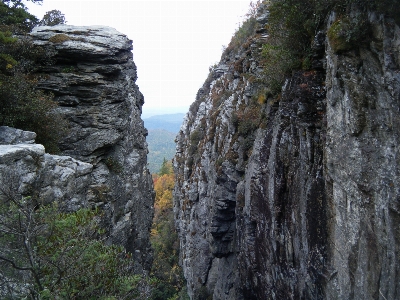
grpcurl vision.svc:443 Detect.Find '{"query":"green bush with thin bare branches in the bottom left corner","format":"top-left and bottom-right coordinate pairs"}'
top-left (0, 185), bottom-right (141, 299)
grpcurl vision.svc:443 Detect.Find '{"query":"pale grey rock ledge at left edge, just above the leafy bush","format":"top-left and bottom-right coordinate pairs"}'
top-left (0, 144), bottom-right (93, 211)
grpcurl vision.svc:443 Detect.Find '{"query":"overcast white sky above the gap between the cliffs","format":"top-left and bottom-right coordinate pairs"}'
top-left (22, 0), bottom-right (250, 118)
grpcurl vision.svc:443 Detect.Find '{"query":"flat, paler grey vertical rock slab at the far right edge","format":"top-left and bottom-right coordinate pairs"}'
top-left (324, 14), bottom-right (400, 299)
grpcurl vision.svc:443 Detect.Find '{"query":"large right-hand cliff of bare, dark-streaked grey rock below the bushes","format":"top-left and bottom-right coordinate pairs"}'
top-left (174, 7), bottom-right (400, 300)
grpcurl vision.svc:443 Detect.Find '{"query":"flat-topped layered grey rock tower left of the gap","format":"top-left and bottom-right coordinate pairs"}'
top-left (1, 25), bottom-right (154, 270)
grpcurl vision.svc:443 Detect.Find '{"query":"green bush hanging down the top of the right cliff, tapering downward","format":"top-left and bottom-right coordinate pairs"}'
top-left (261, 0), bottom-right (333, 95)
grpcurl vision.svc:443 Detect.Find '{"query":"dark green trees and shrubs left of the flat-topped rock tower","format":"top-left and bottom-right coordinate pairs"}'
top-left (0, 0), bottom-right (67, 153)
